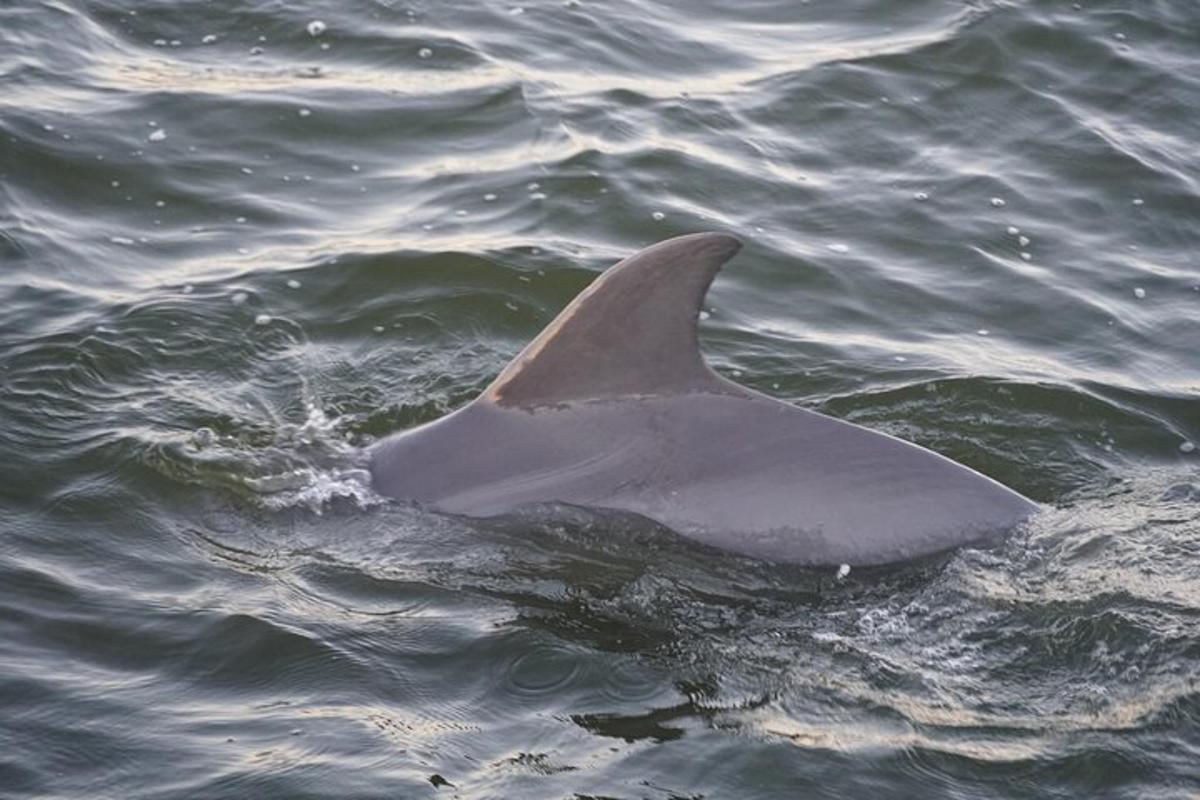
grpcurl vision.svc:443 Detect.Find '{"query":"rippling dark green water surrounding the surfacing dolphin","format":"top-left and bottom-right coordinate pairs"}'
top-left (0, 0), bottom-right (1200, 800)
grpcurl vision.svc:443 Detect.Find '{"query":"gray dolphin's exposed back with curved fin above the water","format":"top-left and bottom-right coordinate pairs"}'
top-left (371, 233), bottom-right (1037, 565)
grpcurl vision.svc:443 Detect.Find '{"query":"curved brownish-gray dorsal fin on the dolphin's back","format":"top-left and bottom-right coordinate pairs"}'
top-left (482, 233), bottom-right (742, 407)
